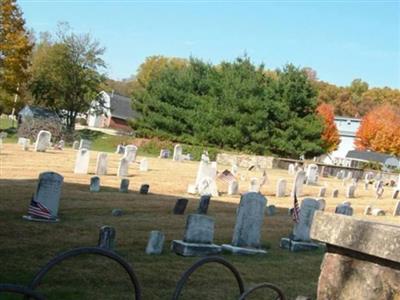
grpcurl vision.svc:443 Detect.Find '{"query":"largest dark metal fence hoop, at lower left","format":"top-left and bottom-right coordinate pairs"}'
top-left (29, 247), bottom-right (142, 300)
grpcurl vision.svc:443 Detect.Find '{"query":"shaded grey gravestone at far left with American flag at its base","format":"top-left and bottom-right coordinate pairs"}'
top-left (23, 172), bottom-right (64, 222)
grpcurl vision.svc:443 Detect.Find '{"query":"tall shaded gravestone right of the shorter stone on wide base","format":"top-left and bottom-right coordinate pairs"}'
top-left (222, 193), bottom-right (267, 255)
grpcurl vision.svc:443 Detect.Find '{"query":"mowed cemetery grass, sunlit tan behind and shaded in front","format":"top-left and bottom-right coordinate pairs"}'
top-left (0, 144), bottom-right (400, 300)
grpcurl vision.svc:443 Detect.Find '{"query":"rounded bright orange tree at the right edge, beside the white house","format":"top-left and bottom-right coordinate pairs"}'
top-left (354, 104), bottom-right (400, 155)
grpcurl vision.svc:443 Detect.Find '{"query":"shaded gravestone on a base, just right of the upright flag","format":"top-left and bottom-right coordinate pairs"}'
top-left (280, 198), bottom-right (320, 252)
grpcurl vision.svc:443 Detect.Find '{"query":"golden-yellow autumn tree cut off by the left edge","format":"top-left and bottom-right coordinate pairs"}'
top-left (0, 0), bottom-right (33, 112)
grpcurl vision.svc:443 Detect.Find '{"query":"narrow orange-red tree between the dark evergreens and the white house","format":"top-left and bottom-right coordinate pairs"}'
top-left (317, 103), bottom-right (340, 152)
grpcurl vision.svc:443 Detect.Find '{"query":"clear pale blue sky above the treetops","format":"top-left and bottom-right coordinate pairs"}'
top-left (18, 0), bottom-right (400, 88)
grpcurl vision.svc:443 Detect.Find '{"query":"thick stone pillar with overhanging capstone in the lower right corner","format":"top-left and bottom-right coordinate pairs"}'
top-left (311, 212), bottom-right (400, 300)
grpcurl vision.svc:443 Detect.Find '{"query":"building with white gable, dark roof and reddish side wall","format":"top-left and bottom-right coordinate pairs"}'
top-left (87, 91), bottom-right (135, 130)
